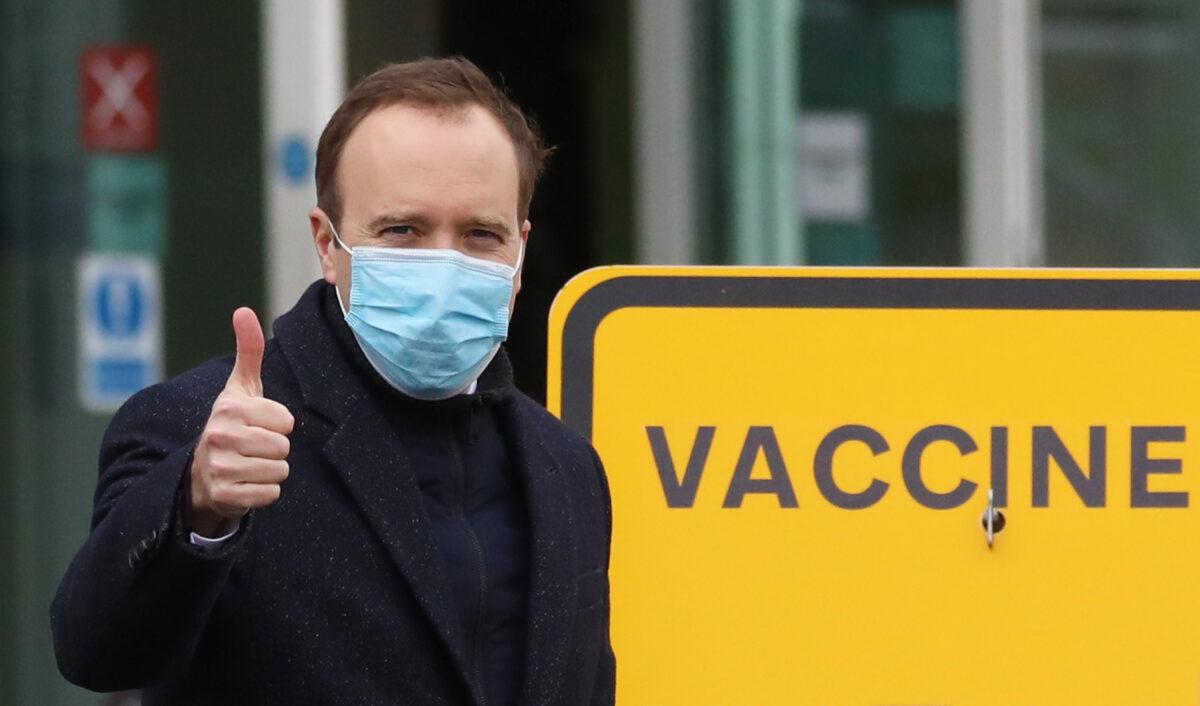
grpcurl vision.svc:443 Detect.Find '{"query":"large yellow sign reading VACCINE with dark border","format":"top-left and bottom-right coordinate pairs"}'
top-left (548, 268), bottom-right (1200, 706)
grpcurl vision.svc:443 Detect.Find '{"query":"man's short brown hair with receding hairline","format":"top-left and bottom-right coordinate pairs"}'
top-left (317, 56), bottom-right (551, 229)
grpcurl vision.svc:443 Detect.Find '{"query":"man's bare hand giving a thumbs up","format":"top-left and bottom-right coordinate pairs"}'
top-left (190, 306), bottom-right (295, 537)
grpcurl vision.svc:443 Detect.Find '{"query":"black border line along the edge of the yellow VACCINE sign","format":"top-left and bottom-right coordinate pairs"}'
top-left (560, 275), bottom-right (1200, 439)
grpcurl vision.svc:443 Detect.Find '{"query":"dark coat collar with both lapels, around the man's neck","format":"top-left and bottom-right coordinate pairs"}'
top-left (274, 281), bottom-right (580, 704)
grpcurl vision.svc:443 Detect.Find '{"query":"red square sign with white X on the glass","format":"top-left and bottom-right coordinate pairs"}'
top-left (79, 44), bottom-right (158, 152)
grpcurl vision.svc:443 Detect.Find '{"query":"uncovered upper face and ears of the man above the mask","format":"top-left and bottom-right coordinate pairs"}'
top-left (310, 104), bottom-right (529, 311)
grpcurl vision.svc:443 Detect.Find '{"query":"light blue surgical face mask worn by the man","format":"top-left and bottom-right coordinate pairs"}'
top-left (329, 223), bottom-right (524, 400)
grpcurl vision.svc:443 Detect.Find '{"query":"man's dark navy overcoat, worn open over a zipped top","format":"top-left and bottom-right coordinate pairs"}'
top-left (50, 282), bottom-right (616, 705)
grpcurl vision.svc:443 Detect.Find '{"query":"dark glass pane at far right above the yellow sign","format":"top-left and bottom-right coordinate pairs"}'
top-left (1042, 0), bottom-right (1200, 267)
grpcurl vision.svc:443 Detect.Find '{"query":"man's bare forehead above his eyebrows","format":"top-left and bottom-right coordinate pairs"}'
top-left (337, 103), bottom-right (518, 219)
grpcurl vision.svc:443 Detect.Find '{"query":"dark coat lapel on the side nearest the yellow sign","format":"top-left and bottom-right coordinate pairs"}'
top-left (504, 396), bottom-right (578, 705)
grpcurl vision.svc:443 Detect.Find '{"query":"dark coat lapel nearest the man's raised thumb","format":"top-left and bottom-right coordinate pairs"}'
top-left (275, 283), bottom-right (481, 702)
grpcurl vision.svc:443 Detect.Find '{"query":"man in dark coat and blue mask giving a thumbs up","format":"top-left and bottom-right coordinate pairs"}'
top-left (50, 59), bottom-right (616, 706)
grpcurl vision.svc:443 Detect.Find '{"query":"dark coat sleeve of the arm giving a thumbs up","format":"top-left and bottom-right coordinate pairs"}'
top-left (50, 376), bottom-right (251, 692)
